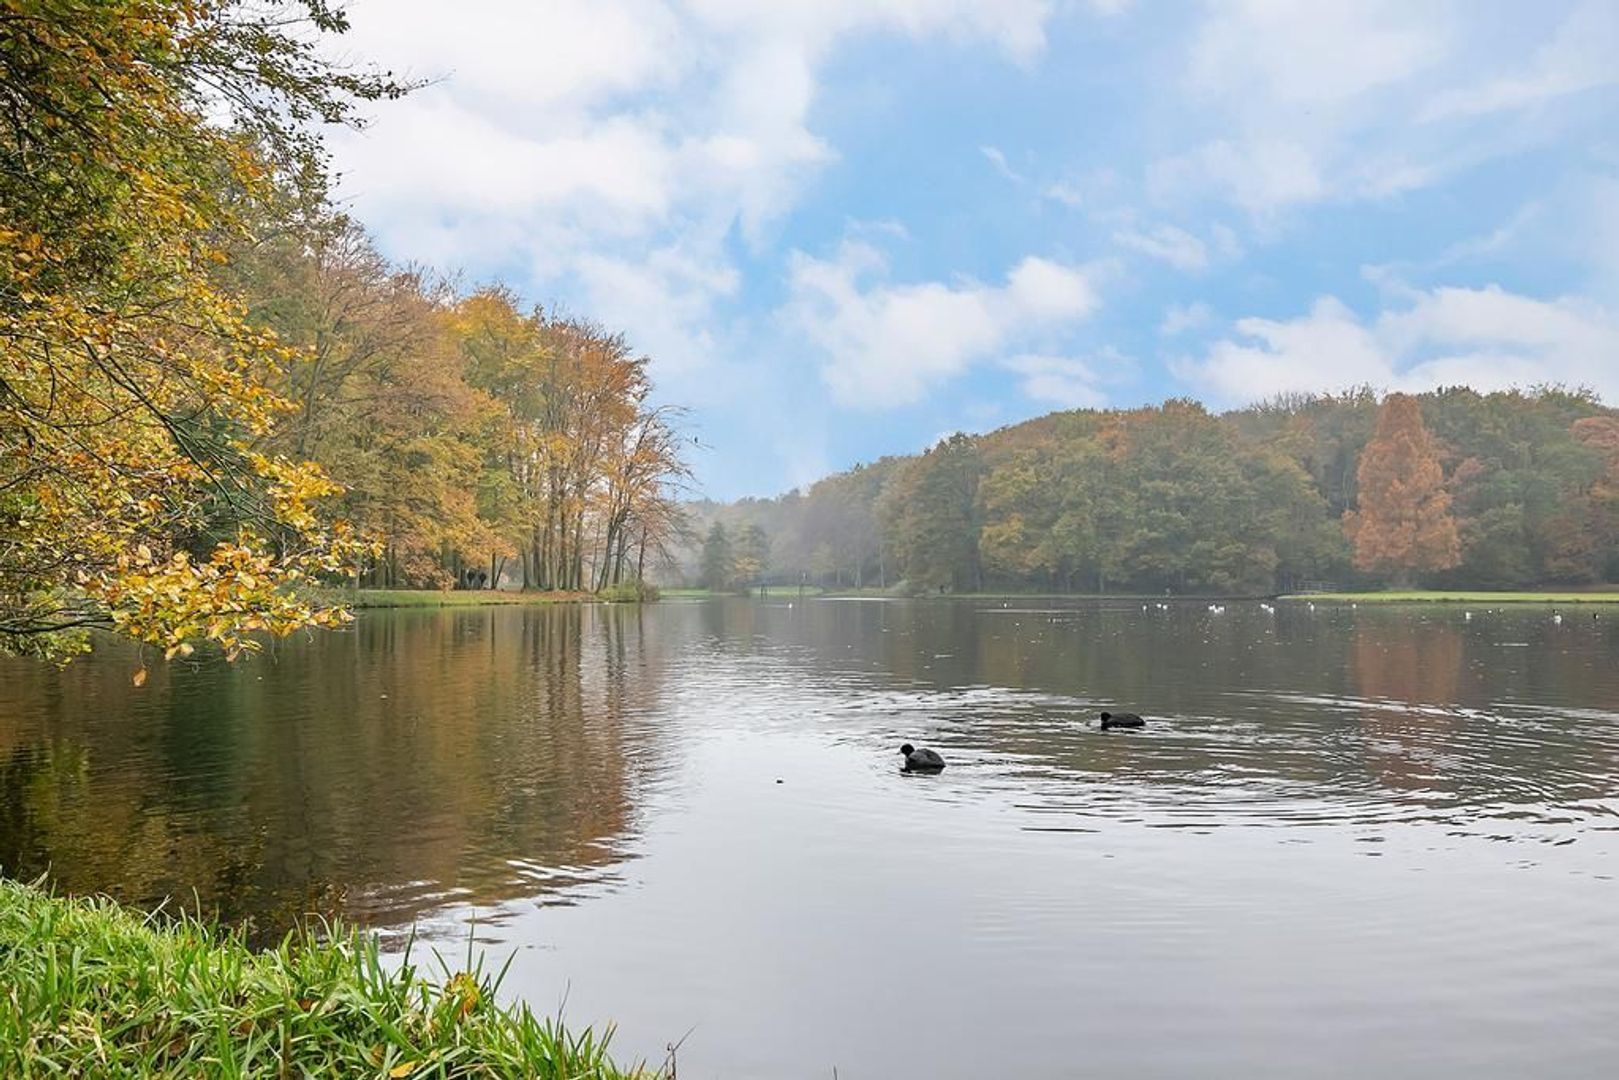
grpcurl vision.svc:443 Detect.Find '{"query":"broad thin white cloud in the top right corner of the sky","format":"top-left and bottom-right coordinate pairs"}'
top-left (1146, 0), bottom-right (1619, 227)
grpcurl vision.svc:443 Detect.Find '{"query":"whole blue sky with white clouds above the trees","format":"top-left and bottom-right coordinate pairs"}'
top-left (330, 0), bottom-right (1619, 499)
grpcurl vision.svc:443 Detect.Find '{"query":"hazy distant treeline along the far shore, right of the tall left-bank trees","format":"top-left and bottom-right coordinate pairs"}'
top-left (683, 389), bottom-right (1619, 593)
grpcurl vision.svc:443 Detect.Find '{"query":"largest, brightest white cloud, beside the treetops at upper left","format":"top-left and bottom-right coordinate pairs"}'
top-left (332, 0), bottom-right (1052, 382)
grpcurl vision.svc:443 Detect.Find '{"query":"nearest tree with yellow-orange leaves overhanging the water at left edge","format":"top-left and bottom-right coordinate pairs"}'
top-left (0, 0), bottom-right (403, 656)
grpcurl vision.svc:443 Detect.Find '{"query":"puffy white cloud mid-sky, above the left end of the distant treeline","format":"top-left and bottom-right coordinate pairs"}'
top-left (784, 243), bottom-right (1098, 408)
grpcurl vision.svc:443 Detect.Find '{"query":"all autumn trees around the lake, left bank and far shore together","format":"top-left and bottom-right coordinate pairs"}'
top-left (0, 0), bottom-right (1619, 676)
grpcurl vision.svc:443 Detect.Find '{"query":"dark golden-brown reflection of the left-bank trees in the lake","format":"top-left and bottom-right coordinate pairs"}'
top-left (0, 604), bottom-right (661, 936)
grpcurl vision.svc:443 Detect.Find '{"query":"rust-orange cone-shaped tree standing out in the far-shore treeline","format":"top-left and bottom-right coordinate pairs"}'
top-left (1344, 393), bottom-right (1462, 586)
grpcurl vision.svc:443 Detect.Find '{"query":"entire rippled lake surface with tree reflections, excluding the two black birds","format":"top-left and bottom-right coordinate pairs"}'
top-left (0, 599), bottom-right (1619, 1080)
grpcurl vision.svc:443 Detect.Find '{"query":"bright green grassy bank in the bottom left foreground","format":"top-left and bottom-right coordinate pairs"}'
top-left (0, 881), bottom-right (654, 1080)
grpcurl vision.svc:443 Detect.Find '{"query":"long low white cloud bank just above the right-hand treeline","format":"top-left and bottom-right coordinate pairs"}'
top-left (1174, 285), bottom-right (1619, 405)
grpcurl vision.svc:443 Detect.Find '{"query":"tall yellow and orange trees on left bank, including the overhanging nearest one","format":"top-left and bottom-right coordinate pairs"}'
top-left (0, 0), bottom-right (685, 657)
